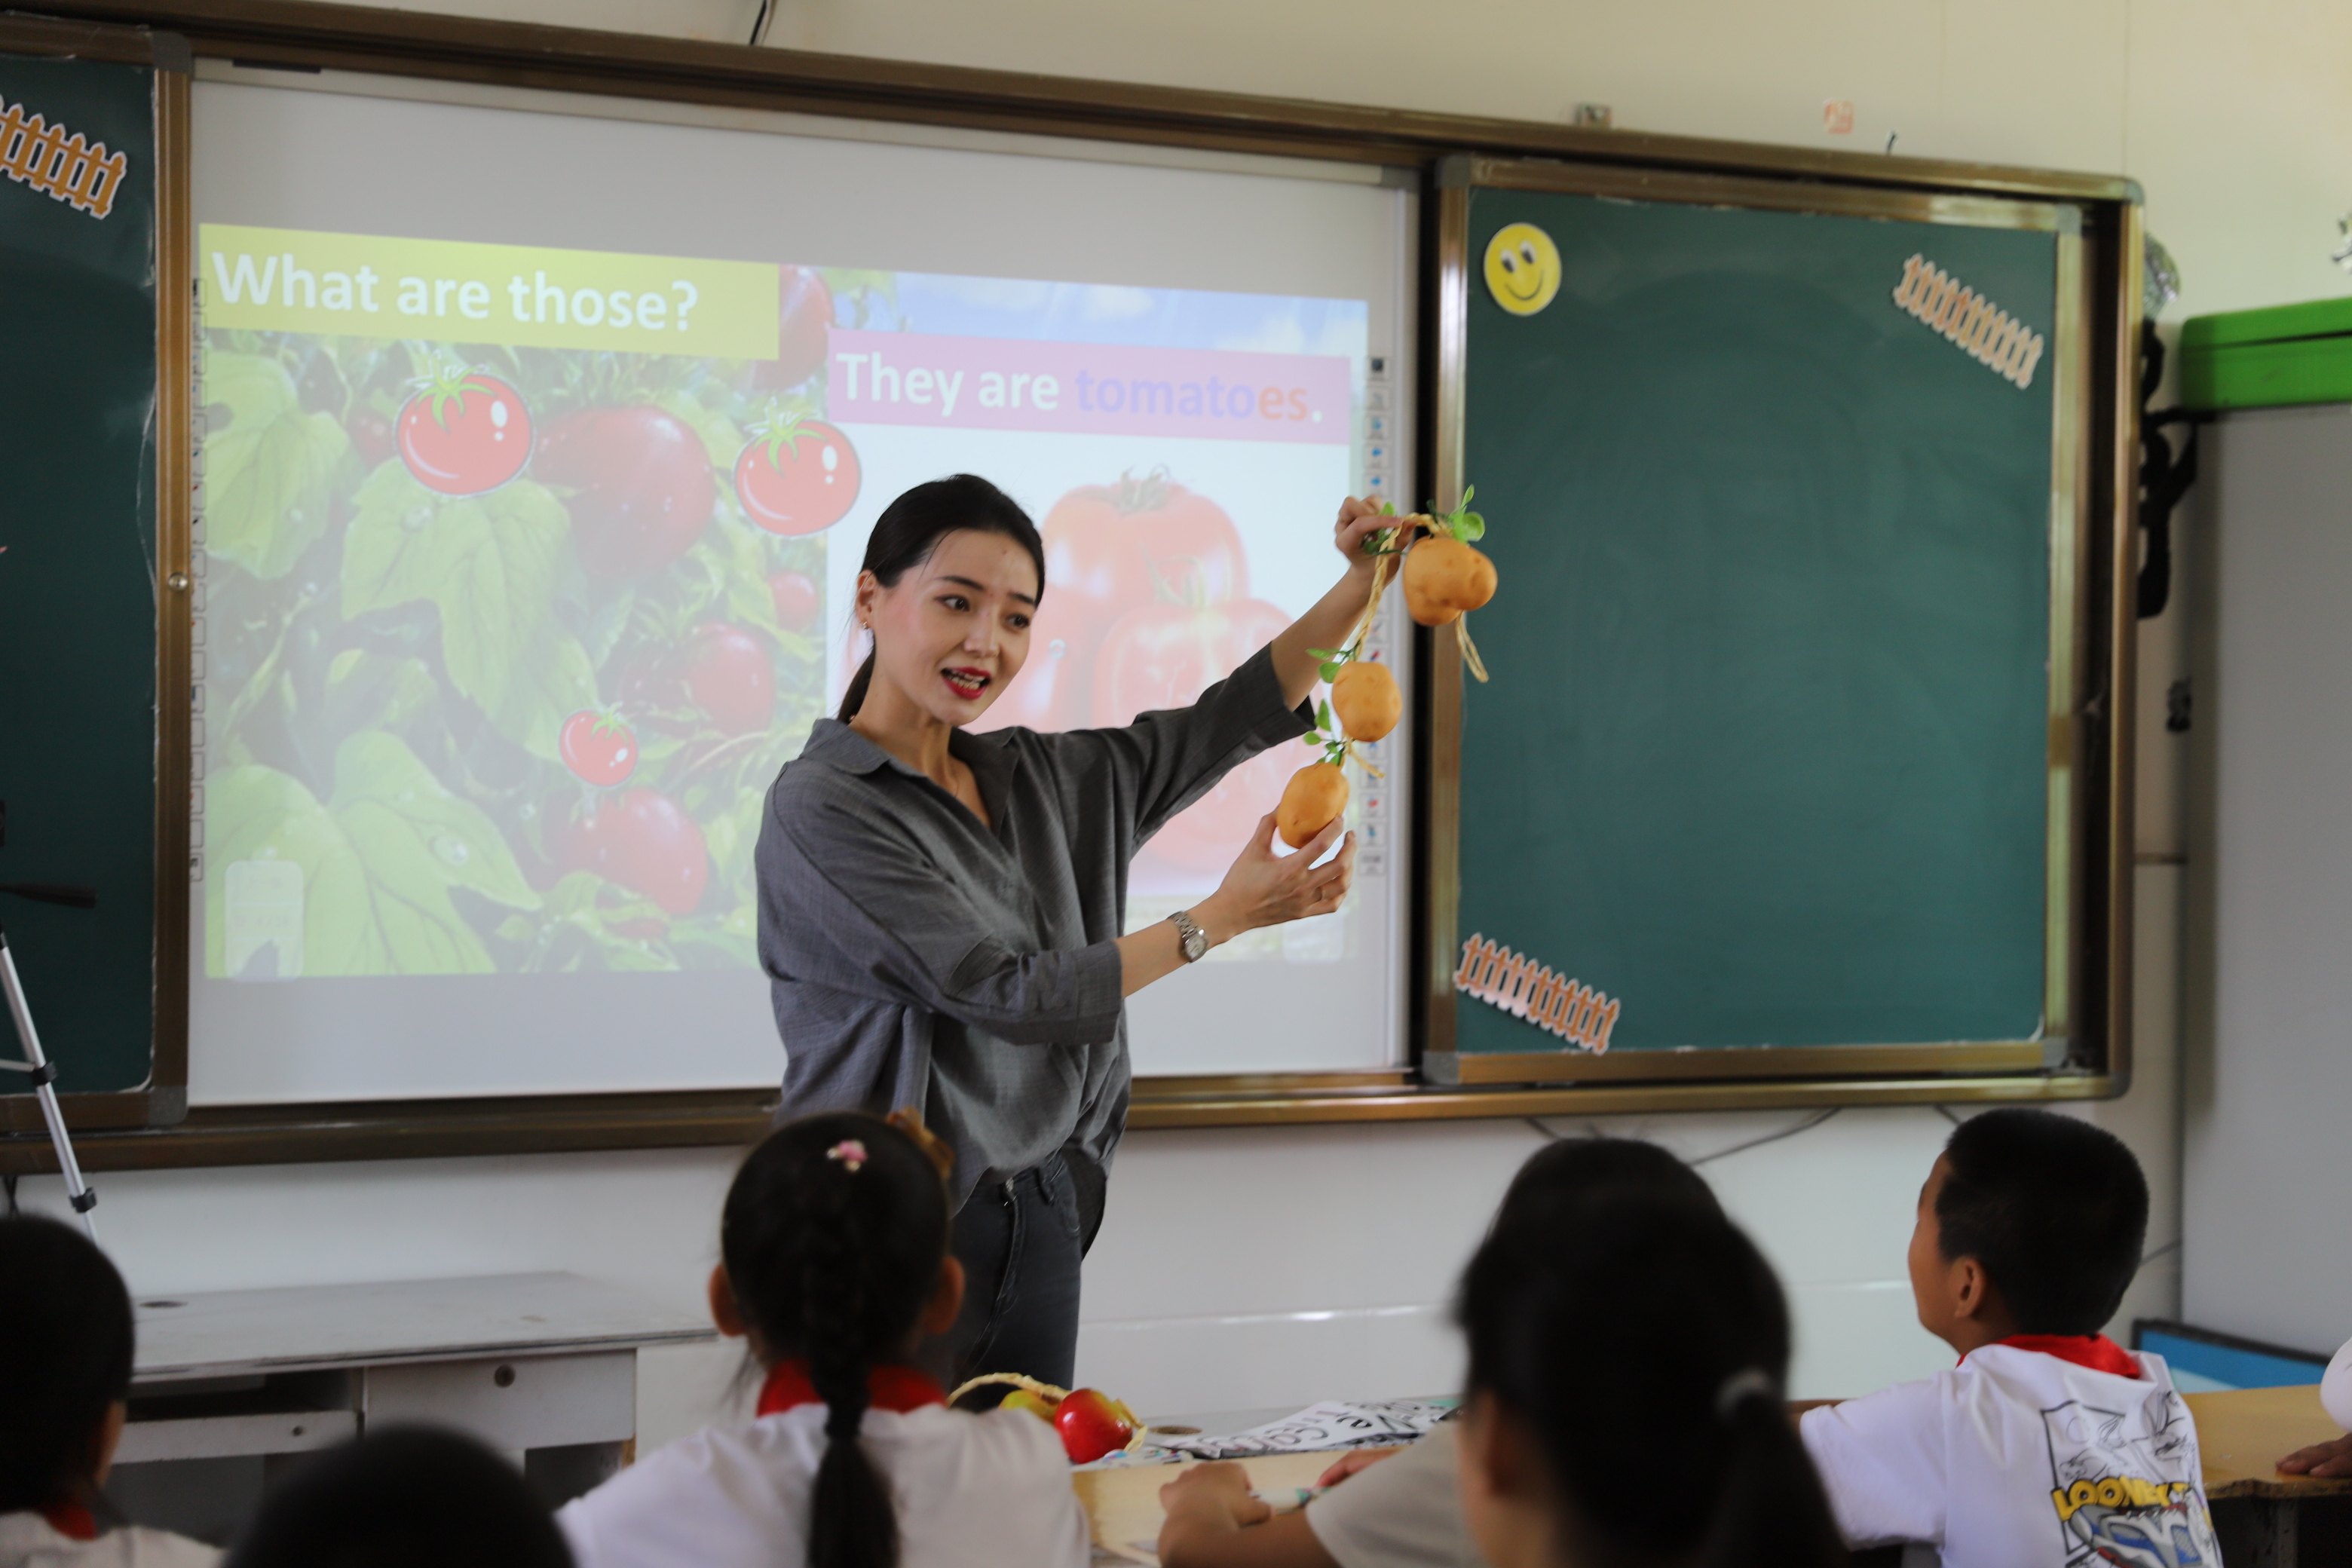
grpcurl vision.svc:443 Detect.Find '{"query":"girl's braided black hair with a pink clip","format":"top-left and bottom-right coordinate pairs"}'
top-left (720, 1112), bottom-right (953, 1568)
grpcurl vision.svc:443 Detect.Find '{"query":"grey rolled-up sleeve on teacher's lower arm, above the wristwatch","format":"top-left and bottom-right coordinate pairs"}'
top-left (760, 801), bottom-right (1122, 1046)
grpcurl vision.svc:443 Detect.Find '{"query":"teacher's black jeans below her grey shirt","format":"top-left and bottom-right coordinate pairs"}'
top-left (924, 1154), bottom-right (1101, 1406)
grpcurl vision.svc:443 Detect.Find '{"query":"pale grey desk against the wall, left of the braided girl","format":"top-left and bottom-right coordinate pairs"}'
top-left (106, 1274), bottom-right (715, 1540)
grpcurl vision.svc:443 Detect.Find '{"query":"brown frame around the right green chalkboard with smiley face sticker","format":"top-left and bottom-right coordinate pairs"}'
top-left (1416, 153), bottom-right (2140, 1110)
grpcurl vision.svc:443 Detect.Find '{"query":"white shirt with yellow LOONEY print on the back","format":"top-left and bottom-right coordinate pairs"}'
top-left (1799, 1345), bottom-right (2220, 1568)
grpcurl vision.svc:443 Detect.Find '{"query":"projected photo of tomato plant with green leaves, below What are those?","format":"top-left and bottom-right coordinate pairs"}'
top-left (200, 268), bottom-right (860, 980)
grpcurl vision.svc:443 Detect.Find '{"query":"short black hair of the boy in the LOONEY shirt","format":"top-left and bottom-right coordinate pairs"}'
top-left (1936, 1105), bottom-right (2148, 1333)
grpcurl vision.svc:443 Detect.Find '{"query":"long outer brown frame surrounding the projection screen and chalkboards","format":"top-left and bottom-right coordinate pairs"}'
top-left (0, 0), bottom-right (2140, 1171)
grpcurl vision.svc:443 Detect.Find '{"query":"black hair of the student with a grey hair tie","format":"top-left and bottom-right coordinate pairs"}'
top-left (1456, 1187), bottom-right (1846, 1568)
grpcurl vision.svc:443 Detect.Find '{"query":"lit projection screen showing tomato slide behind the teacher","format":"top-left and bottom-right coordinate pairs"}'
top-left (191, 73), bottom-right (1413, 1103)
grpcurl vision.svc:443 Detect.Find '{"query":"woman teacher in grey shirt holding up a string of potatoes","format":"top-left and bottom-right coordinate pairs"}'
top-left (758, 475), bottom-right (1383, 1387)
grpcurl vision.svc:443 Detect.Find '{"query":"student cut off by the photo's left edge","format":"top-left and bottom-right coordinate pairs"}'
top-left (0, 1215), bottom-right (221, 1568)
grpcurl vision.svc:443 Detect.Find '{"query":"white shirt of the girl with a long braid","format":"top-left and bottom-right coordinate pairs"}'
top-left (555, 1404), bottom-right (1092, 1568)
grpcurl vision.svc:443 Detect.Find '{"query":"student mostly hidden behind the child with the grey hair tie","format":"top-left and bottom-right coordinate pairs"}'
top-left (1159, 1138), bottom-right (1722, 1568)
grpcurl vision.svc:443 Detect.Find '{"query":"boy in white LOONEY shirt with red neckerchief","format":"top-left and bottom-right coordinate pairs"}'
top-left (1802, 1110), bottom-right (2220, 1568)
